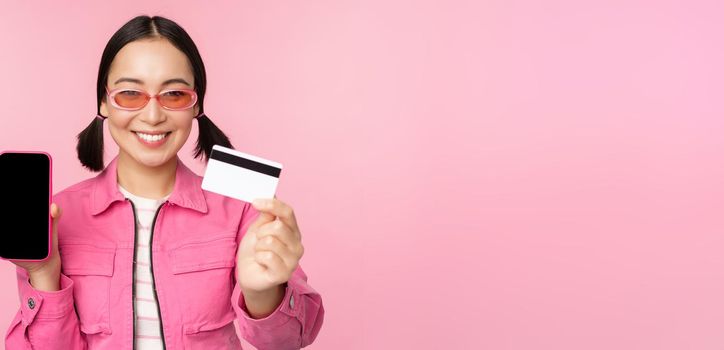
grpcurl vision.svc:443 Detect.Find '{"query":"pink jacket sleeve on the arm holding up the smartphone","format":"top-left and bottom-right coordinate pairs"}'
top-left (5, 266), bottom-right (87, 350)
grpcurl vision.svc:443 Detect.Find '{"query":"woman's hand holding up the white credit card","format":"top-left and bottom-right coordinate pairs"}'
top-left (236, 198), bottom-right (304, 316)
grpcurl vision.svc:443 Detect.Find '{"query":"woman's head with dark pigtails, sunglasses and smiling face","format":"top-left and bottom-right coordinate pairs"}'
top-left (77, 16), bottom-right (231, 175)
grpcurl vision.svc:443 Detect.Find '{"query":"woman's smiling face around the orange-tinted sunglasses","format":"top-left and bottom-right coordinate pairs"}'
top-left (101, 39), bottom-right (199, 167)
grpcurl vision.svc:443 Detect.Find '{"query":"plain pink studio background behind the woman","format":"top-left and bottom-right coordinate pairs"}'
top-left (0, 0), bottom-right (724, 350)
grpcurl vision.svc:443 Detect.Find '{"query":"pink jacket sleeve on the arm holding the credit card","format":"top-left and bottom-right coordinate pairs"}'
top-left (231, 204), bottom-right (324, 350)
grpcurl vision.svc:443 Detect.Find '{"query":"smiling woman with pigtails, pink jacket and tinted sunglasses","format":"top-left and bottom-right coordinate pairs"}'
top-left (5, 16), bottom-right (324, 349)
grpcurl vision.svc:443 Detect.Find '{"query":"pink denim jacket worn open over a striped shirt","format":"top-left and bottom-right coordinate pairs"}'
top-left (5, 157), bottom-right (324, 350)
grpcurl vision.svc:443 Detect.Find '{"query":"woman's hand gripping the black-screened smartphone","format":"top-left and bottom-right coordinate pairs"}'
top-left (9, 203), bottom-right (62, 291)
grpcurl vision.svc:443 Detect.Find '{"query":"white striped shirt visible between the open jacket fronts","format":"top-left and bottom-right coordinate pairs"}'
top-left (118, 185), bottom-right (169, 350)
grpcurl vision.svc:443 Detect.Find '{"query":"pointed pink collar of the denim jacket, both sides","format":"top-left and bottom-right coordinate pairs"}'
top-left (91, 156), bottom-right (208, 215)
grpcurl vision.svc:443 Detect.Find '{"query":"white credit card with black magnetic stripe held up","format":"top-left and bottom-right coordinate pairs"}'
top-left (201, 145), bottom-right (282, 202)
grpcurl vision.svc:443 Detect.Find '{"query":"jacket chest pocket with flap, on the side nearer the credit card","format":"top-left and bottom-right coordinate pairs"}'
top-left (168, 236), bottom-right (237, 328)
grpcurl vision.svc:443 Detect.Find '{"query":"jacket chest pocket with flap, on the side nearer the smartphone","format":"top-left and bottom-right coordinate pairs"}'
top-left (58, 244), bottom-right (116, 334)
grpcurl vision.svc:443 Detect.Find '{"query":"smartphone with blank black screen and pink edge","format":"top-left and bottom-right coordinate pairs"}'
top-left (0, 151), bottom-right (53, 261)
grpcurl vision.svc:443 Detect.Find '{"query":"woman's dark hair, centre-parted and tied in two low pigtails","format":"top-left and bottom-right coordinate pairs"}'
top-left (76, 16), bottom-right (233, 171)
